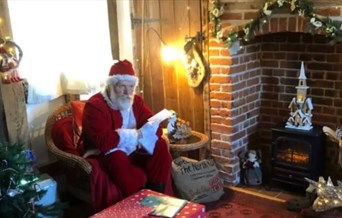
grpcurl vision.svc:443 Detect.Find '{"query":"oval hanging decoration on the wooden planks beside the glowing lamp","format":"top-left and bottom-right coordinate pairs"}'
top-left (184, 39), bottom-right (206, 87)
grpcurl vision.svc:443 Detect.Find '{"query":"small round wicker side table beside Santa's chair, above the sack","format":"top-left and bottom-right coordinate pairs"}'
top-left (169, 130), bottom-right (209, 160)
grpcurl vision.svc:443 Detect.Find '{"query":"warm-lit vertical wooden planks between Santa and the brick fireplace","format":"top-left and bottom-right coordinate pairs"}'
top-left (133, 0), bottom-right (208, 132)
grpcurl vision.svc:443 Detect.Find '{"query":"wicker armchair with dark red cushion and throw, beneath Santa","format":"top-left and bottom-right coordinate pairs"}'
top-left (45, 102), bottom-right (173, 212)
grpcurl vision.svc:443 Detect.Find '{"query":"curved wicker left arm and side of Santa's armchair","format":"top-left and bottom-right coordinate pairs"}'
top-left (45, 103), bottom-right (92, 203)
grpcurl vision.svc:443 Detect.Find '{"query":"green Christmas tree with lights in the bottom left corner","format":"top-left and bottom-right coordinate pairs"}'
top-left (0, 143), bottom-right (66, 218)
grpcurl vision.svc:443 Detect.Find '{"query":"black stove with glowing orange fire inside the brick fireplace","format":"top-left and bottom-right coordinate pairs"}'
top-left (271, 125), bottom-right (325, 188)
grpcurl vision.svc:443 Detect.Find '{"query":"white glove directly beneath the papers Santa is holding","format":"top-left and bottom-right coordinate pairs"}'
top-left (138, 122), bottom-right (159, 154)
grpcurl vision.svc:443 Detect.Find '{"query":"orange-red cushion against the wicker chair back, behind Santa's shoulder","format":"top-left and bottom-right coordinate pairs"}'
top-left (70, 101), bottom-right (85, 148)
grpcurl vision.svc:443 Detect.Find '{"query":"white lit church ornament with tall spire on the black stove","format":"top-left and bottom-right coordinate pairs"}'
top-left (285, 61), bottom-right (313, 130)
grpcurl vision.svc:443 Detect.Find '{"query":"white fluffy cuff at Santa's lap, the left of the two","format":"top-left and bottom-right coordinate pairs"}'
top-left (116, 129), bottom-right (138, 155)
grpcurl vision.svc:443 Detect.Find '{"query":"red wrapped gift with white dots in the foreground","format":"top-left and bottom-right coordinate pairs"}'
top-left (90, 189), bottom-right (205, 218)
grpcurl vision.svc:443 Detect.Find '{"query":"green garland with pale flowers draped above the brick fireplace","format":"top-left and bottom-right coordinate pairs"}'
top-left (209, 0), bottom-right (342, 48)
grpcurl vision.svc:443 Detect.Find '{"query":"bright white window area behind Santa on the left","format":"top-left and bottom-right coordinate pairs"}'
top-left (8, 0), bottom-right (113, 103)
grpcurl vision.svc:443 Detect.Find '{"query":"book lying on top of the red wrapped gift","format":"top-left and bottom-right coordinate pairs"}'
top-left (140, 195), bottom-right (188, 218)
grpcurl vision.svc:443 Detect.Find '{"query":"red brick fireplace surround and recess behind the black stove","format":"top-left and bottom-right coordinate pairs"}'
top-left (209, 0), bottom-right (342, 185)
